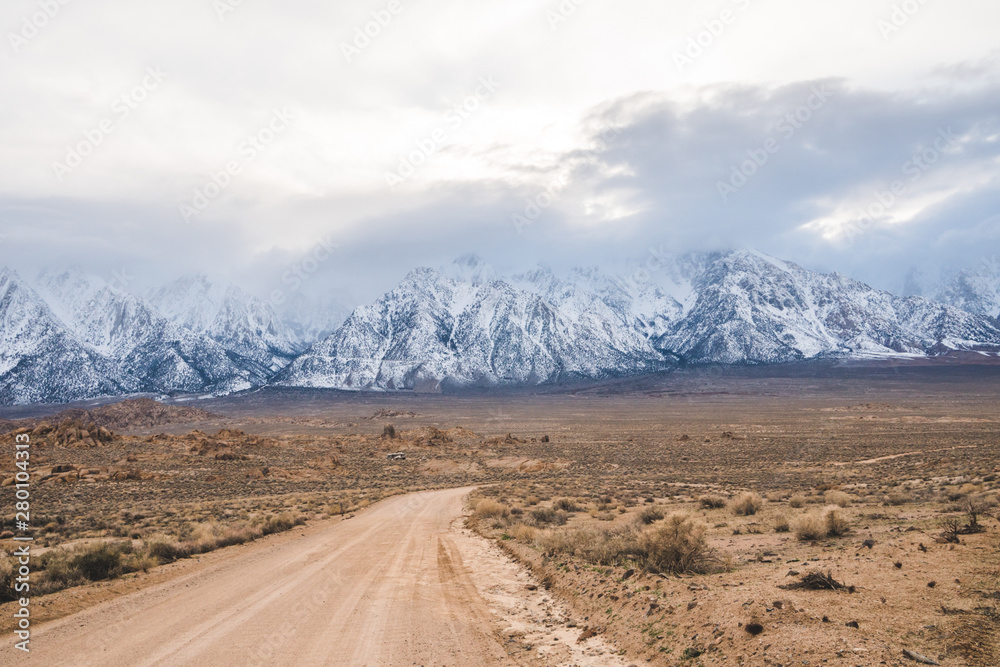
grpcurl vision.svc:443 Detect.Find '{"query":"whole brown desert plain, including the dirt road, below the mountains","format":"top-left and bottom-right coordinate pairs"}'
top-left (0, 358), bottom-right (1000, 666)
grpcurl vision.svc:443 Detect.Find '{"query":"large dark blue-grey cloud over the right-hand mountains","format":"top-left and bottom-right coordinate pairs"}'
top-left (536, 67), bottom-right (1000, 290)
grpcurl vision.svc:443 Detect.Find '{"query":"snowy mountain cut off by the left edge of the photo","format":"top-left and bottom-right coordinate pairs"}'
top-left (0, 268), bottom-right (127, 405)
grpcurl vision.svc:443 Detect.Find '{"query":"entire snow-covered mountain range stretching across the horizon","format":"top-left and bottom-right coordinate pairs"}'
top-left (0, 250), bottom-right (1000, 404)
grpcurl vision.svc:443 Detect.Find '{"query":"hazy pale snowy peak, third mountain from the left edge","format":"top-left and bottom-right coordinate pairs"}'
top-left (147, 275), bottom-right (306, 380)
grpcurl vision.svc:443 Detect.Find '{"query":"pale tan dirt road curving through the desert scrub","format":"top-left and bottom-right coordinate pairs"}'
top-left (9, 489), bottom-right (516, 667)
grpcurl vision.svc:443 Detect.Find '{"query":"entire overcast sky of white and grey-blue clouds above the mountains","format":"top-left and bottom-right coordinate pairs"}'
top-left (0, 0), bottom-right (1000, 299)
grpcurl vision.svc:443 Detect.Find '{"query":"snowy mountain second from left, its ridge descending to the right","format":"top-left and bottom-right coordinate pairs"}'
top-left (35, 271), bottom-right (256, 392)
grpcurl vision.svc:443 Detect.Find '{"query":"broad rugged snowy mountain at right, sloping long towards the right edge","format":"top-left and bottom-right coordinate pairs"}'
top-left (654, 251), bottom-right (1000, 363)
